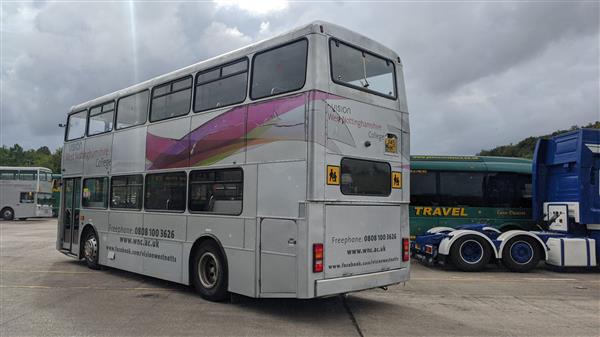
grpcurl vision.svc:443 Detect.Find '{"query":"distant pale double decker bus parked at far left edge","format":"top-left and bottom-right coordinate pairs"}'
top-left (0, 166), bottom-right (52, 220)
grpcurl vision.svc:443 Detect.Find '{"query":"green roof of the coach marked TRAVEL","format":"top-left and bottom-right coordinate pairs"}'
top-left (410, 156), bottom-right (532, 174)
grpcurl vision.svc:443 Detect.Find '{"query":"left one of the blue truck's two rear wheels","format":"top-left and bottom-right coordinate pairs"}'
top-left (450, 235), bottom-right (492, 272)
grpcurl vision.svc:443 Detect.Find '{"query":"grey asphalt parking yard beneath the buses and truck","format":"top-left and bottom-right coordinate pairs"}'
top-left (0, 219), bottom-right (600, 336)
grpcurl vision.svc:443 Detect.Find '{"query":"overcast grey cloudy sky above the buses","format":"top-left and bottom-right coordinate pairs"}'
top-left (0, 1), bottom-right (600, 154)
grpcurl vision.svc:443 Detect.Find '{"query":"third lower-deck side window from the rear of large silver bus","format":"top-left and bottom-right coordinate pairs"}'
top-left (110, 174), bottom-right (144, 210)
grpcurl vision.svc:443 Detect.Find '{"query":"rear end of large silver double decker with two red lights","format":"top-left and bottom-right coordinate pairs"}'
top-left (307, 24), bottom-right (410, 296)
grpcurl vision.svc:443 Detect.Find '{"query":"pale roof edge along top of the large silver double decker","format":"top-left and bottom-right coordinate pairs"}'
top-left (69, 21), bottom-right (400, 114)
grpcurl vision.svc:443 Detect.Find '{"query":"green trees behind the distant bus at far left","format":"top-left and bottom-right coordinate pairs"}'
top-left (0, 144), bottom-right (62, 173)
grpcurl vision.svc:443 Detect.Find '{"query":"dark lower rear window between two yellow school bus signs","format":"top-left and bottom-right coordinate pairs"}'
top-left (341, 158), bottom-right (392, 196)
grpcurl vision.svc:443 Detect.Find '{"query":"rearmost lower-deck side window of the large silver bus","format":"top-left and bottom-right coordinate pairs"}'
top-left (189, 168), bottom-right (244, 215)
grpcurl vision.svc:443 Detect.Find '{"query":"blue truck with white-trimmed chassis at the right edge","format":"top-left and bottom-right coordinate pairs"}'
top-left (411, 129), bottom-right (600, 272)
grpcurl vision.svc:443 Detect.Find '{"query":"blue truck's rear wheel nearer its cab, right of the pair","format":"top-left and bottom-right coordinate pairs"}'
top-left (502, 235), bottom-right (542, 273)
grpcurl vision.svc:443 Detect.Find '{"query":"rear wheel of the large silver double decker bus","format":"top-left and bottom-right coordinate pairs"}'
top-left (190, 241), bottom-right (229, 302)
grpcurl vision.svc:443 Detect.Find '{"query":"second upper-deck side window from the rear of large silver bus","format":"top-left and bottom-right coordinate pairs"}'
top-left (194, 59), bottom-right (248, 112)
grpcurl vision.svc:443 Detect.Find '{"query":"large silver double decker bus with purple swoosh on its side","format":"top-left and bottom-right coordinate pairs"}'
top-left (56, 22), bottom-right (410, 300)
